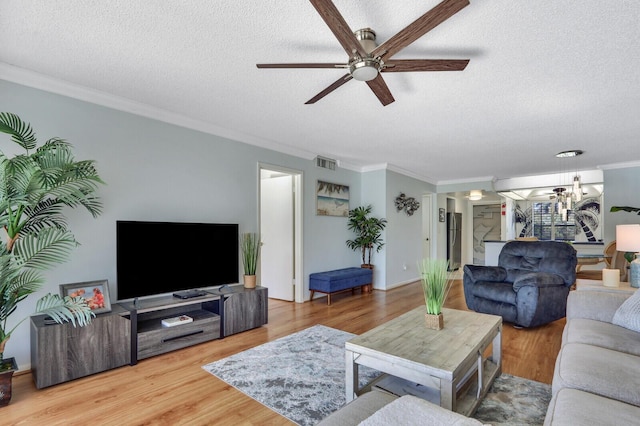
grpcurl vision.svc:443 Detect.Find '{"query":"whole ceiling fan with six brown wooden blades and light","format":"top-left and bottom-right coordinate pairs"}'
top-left (256, 0), bottom-right (469, 106)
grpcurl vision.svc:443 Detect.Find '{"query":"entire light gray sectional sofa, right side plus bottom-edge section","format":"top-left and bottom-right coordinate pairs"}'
top-left (320, 290), bottom-right (640, 426)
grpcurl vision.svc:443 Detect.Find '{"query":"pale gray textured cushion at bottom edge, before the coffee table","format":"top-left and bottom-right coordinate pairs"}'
top-left (360, 395), bottom-right (482, 426)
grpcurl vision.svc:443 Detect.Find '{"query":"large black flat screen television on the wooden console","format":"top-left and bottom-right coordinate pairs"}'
top-left (116, 221), bottom-right (239, 300)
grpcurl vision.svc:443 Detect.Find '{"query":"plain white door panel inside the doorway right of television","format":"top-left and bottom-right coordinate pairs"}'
top-left (260, 173), bottom-right (294, 301)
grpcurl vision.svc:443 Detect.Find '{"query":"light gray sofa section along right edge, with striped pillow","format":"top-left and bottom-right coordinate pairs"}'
top-left (545, 290), bottom-right (640, 425)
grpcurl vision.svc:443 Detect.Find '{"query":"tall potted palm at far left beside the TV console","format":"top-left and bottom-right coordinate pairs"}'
top-left (0, 113), bottom-right (102, 405)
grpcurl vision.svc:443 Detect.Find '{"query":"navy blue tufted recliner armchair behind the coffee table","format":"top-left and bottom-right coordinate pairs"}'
top-left (463, 241), bottom-right (577, 327)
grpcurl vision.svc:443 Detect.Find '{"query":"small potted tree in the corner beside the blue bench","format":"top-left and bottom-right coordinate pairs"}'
top-left (347, 205), bottom-right (387, 268)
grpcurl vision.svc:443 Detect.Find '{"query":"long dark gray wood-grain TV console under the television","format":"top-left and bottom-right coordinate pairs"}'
top-left (31, 284), bottom-right (268, 388)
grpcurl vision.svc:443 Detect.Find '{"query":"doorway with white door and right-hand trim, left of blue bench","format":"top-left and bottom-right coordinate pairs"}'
top-left (259, 164), bottom-right (304, 303)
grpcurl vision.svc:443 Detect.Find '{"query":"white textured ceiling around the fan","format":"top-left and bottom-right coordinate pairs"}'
top-left (0, 0), bottom-right (640, 183)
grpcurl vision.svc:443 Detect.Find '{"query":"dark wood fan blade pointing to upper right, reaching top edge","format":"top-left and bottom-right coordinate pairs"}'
top-left (371, 0), bottom-right (469, 58)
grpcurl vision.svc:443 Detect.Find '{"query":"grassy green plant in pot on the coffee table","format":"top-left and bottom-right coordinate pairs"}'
top-left (418, 259), bottom-right (453, 330)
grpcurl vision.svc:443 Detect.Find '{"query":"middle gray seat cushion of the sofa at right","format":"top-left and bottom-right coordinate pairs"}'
top-left (552, 343), bottom-right (640, 406)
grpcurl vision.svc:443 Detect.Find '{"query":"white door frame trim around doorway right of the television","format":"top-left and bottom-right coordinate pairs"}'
top-left (258, 163), bottom-right (304, 303)
